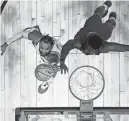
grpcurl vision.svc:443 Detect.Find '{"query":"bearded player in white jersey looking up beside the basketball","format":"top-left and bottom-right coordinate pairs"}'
top-left (1, 25), bottom-right (62, 93)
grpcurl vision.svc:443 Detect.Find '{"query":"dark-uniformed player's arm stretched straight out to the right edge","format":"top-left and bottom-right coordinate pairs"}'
top-left (100, 42), bottom-right (129, 53)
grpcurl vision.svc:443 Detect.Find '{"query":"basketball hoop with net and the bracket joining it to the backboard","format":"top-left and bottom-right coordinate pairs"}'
top-left (69, 66), bottom-right (105, 121)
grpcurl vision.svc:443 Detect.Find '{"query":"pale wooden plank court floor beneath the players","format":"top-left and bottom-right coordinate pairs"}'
top-left (0, 0), bottom-right (129, 121)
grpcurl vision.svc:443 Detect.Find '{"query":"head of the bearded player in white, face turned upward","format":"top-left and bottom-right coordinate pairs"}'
top-left (39, 35), bottom-right (54, 56)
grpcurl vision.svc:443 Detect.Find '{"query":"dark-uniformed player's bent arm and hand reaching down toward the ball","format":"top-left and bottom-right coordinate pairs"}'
top-left (60, 40), bottom-right (76, 74)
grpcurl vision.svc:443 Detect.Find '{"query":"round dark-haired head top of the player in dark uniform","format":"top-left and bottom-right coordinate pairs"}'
top-left (88, 35), bottom-right (103, 49)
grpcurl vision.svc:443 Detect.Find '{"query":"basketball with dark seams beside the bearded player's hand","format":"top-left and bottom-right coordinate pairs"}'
top-left (35, 64), bottom-right (55, 81)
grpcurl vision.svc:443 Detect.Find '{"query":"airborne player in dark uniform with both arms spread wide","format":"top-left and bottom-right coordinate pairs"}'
top-left (60, 1), bottom-right (129, 73)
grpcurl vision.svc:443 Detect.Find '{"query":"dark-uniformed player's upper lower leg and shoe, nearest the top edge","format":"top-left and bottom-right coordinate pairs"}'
top-left (94, 1), bottom-right (112, 18)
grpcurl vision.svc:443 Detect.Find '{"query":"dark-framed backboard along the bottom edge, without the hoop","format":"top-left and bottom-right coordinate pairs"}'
top-left (15, 107), bottom-right (129, 121)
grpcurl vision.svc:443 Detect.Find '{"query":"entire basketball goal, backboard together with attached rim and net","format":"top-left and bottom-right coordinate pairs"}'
top-left (15, 66), bottom-right (129, 121)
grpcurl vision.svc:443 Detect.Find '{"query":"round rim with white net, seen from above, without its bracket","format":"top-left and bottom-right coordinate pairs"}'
top-left (69, 66), bottom-right (105, 100)
